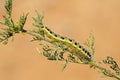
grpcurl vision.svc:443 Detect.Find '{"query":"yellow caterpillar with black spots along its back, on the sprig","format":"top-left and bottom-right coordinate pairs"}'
top-left (40, 25), bottom-right (92, 61)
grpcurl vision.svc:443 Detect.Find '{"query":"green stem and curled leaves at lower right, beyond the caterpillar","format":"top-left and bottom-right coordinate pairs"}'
top-left (89, 56), bottom-right (120, 80)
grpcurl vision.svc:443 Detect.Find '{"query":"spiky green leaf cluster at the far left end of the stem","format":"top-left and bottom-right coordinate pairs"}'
top-left (0, 0), bottom-right (28, 44)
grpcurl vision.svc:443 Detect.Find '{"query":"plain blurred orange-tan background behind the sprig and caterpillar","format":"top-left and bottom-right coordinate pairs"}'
top-left (0, 0), bottom-right (120, 80)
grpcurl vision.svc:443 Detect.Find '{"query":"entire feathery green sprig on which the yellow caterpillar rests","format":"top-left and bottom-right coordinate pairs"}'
top-left (0, 0), bottom-right (120, 80)
